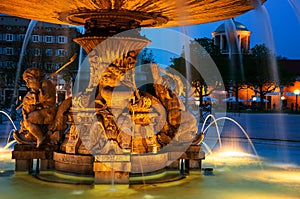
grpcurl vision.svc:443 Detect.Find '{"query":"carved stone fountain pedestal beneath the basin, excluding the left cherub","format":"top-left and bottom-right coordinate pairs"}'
top-left (10, 9), bottom-right (204, 184)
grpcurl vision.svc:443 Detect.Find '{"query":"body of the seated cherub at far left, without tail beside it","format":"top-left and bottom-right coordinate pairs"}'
top-left (17, 68), bottom-right (56, 147)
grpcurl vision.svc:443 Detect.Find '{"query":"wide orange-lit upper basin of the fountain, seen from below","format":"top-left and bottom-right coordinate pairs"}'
top-left (0, 0), bottom-right (266, 27)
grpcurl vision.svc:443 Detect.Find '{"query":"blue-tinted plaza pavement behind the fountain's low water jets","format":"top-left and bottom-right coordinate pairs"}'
top-left (0, 113), bottom-right (300, 142)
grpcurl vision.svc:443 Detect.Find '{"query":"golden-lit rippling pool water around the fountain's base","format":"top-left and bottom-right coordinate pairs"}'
top-left (0, 138), bottom-right (300, 199)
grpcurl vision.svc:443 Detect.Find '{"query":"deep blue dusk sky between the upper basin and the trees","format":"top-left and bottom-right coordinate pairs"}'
top-left (143, 0), bottom-right (300, 65)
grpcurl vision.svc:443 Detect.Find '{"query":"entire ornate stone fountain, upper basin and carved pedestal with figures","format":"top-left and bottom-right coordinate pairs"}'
top-left (0, 0), bottom-right (264, 183)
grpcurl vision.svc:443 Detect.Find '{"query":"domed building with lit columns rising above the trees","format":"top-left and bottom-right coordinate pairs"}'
top-left (212, 20), bottom-right (251, 54)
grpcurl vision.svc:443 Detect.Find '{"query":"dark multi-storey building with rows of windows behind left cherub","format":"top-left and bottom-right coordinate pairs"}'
top-left (0, 15), bottom-right (79, 106)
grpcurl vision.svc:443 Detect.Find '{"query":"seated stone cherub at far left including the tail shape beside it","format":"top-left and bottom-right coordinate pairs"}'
top-left (14, 68), bottom-right (71, 148)
